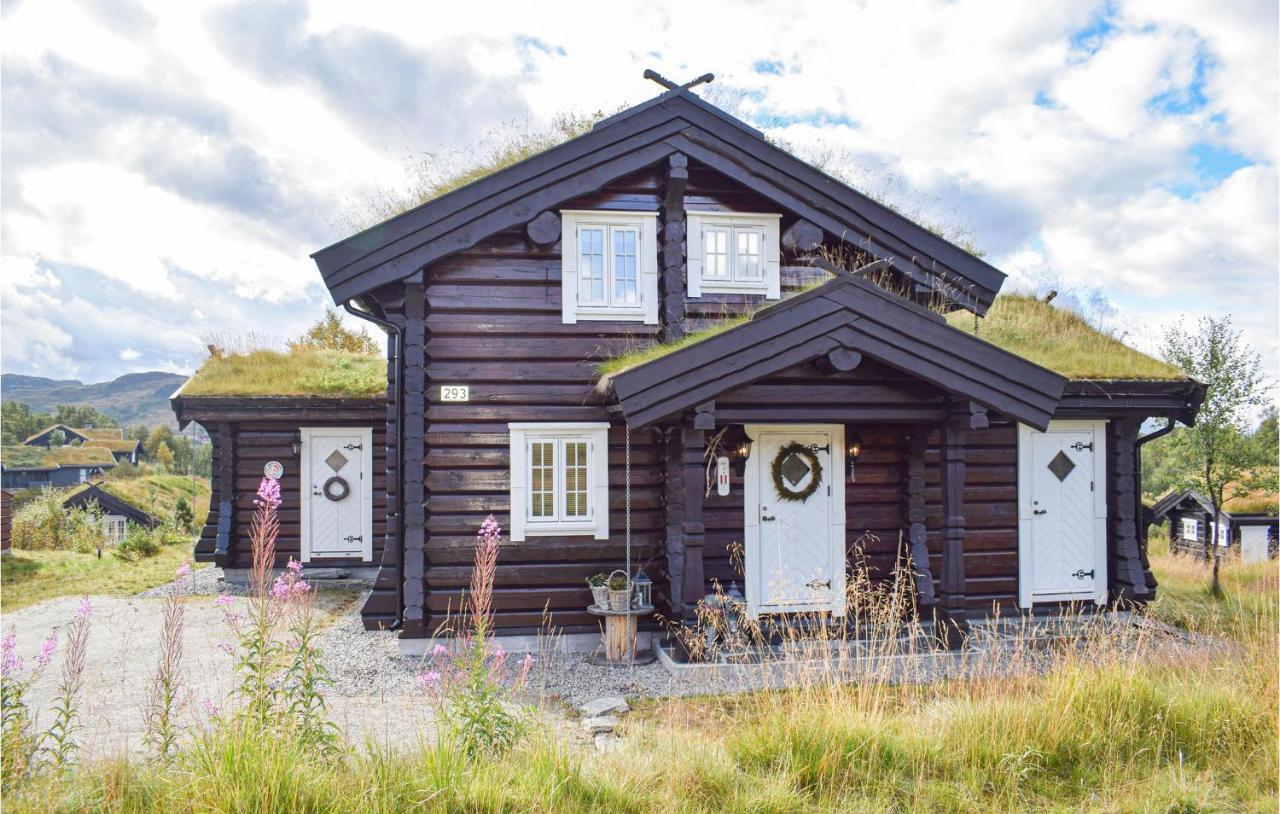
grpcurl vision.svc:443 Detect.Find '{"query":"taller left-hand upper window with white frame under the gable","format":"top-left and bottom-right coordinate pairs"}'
top-left (561, 210), bottom-right (658, 325)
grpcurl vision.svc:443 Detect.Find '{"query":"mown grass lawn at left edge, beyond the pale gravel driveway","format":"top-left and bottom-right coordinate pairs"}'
top-left (0, 543), bottom-right (196, 612)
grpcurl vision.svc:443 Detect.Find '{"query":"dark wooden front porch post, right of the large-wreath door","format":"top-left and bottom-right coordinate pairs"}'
top-left (936, 403), bottom-right (973, 649)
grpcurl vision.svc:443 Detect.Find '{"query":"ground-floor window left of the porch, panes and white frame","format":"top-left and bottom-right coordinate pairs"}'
top-left (507, 421), bottom-right (609, 541)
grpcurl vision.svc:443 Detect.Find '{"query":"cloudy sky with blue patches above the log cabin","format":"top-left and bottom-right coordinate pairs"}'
top-left (0, 0), bottom-right (1280, 381)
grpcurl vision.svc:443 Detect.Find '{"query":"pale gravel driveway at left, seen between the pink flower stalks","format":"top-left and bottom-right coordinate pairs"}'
top-left (0, 591), bottom-right (431, 758)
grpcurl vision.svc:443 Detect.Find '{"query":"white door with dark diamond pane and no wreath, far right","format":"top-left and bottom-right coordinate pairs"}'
top-left (1018, 421), bottom-right (1107, 608)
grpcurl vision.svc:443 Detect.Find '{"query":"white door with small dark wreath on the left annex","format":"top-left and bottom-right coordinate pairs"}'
top-left (301, 427), bottom-right (374, 562)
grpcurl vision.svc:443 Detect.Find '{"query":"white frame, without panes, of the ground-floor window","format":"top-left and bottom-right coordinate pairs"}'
top-left (507, 421), bottom-right (609, 543)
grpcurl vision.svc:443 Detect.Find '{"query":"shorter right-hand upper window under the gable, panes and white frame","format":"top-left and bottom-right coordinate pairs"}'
top-left (685, 211), bottom-right (782, 299)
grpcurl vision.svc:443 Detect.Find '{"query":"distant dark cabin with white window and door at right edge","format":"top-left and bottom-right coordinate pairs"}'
top-left (1151, 489), bottom-right (1280, 562)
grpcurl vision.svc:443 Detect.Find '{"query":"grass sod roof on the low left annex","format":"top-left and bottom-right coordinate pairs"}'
top-left (179, 349), bottom-right (387, 398)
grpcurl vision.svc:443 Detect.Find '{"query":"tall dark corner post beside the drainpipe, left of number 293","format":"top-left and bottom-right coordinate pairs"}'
top-left (401, 275), bottom-right (428, 637)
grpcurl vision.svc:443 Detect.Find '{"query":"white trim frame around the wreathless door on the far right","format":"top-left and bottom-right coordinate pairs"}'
top-left (1018, 419), bottom-right (1108, 608)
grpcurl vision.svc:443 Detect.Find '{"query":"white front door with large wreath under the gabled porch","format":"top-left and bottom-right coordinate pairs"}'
top-left (744, 425), bottom-right (845, 617)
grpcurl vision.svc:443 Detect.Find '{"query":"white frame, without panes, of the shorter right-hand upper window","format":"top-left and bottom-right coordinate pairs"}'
top-left (685, 210), bottom-right (782, 299)
